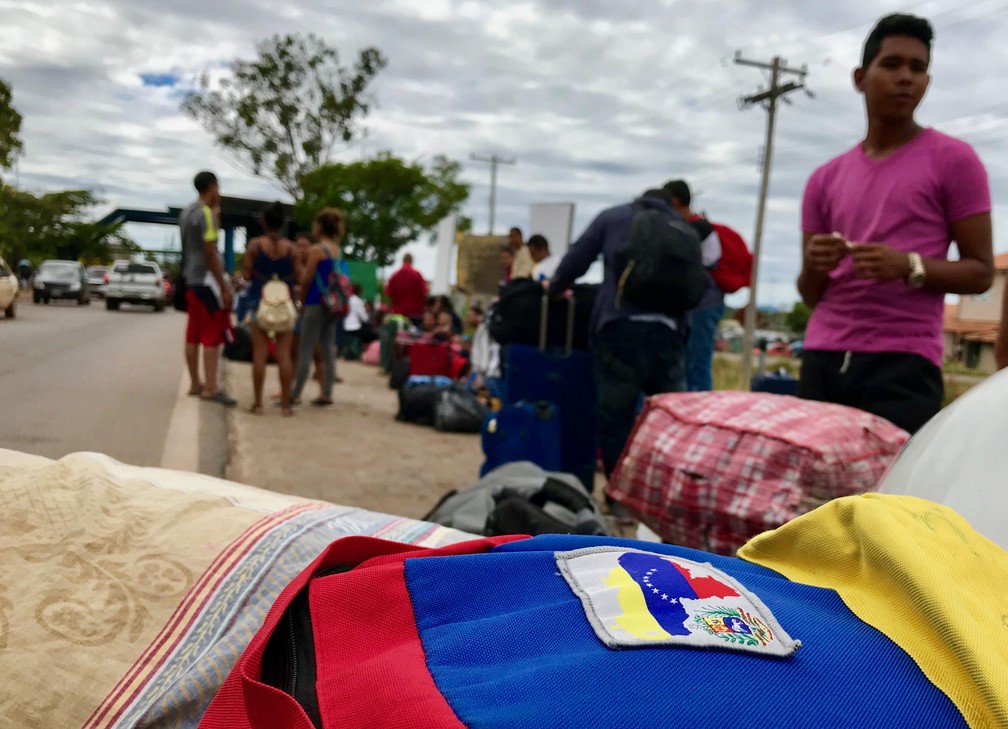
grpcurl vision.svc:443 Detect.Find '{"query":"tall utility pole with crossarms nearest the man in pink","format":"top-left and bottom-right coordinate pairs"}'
top-left (735, 50), bottom-right (808, 389)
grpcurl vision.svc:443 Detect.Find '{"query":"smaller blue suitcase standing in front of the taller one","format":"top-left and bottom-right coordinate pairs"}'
top-left (480, 401), bottom-right (562, 476)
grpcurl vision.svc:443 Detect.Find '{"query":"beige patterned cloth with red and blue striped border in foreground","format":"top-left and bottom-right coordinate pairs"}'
top-left (0, 450), bottom-right (468, 727)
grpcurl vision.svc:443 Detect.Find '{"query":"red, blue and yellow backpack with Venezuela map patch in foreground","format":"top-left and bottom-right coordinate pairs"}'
top-left (201, 494), bottom-right (1008, 729)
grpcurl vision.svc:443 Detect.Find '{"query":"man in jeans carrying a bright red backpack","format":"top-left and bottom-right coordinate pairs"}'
top-left (665, 179), bottom-right (753, 392)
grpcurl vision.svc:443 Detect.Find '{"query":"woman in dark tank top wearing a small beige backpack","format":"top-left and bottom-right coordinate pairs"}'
top-left (242, 203), bottom-right (299, 416)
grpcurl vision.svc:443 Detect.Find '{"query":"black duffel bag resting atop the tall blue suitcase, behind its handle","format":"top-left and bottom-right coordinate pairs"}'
top-left (487, 278), bottom-right (599, 350)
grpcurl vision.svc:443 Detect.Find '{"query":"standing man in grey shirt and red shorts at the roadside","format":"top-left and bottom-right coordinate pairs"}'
top-left (178, 171), bottom-right (235, 406)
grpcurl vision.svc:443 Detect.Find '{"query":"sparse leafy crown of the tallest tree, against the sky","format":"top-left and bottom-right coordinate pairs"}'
top-left (181, 33), bottom-right (388, 198)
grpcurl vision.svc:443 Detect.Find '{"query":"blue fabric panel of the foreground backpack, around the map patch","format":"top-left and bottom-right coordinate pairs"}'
top-left (406, 536), bottom-right (966, 729)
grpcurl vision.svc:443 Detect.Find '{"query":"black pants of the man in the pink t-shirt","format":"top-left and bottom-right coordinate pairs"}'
top-left (798, 350), bottom-right (944, 434)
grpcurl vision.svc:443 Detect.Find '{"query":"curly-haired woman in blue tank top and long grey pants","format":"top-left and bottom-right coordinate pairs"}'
top-left (293, 208), bottom-right (346, 407)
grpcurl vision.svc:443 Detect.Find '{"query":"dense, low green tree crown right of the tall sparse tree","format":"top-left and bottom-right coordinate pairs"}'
top-left (294, 152), bottom-right (469, 266)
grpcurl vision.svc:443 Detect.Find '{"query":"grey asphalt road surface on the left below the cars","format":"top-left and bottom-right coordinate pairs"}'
top-left (0, 298), bottom-right (226, 475)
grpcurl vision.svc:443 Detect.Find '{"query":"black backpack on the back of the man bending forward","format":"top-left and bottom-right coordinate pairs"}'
top-left (616, 204), bottom-right (711, 317)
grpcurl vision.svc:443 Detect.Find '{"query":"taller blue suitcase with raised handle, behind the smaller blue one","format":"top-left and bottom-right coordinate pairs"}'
top-left (504, 296), bottom-right (598, 492)
